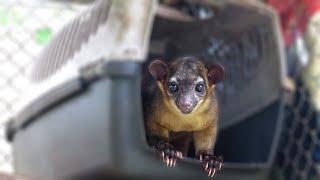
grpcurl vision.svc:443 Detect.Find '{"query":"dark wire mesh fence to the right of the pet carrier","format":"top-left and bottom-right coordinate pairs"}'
top-left (278, 78), bottom-right (320, 180)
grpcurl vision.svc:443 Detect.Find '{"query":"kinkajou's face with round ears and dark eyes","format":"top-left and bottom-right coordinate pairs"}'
top-left (149, 57), bottom-right (224, 114)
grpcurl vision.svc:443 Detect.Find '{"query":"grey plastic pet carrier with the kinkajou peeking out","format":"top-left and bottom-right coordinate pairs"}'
top-left (7, 0), bottom-right (285, 180)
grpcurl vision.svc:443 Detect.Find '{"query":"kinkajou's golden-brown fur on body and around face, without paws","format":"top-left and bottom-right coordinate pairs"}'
top-left (142, 57), bottom-right (218, 156)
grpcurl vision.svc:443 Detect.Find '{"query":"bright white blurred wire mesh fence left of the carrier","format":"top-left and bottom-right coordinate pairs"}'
top-left (0, 0), bottom-right (87, 172)
